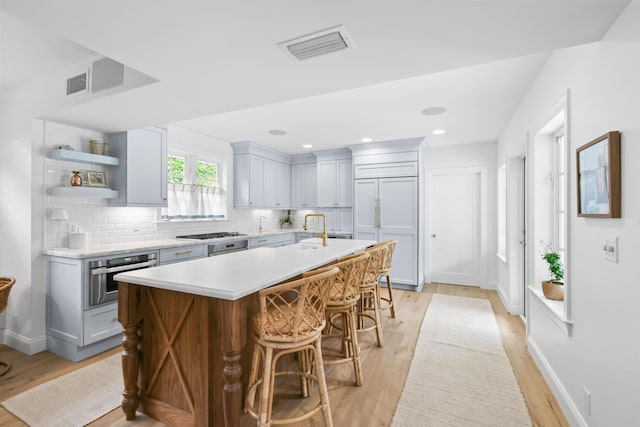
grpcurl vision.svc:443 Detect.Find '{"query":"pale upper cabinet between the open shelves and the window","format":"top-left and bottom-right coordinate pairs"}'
top-left (109, 127), bottom-right (167, 206)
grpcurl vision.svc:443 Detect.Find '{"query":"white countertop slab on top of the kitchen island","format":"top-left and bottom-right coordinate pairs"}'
top-left (114, 238), bottom-right (377, 300)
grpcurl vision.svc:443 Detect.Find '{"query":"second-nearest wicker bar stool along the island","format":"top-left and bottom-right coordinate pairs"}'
top-left (308, 252), bottom-right (371, 386)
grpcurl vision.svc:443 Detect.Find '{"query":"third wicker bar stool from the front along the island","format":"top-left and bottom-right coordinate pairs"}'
top-left (356, 243), bottom-right (388, 347)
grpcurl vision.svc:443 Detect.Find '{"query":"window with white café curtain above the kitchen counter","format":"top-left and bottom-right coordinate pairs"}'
top-left (162, 153), bottom-right (227, 221)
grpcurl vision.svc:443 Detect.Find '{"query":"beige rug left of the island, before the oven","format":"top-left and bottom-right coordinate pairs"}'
top-left (2, 354), bottom-right (123, 427)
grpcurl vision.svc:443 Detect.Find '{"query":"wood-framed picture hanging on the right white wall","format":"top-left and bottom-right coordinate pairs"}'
top-left (576, 131), bottom-right (621, 218)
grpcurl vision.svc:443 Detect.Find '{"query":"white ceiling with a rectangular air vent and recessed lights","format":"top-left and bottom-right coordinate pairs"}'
top-left (0, 0), bottom-right (629, 154)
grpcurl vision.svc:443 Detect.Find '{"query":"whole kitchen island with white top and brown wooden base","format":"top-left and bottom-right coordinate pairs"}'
top-left (115, 239), bottom-right (376, 426)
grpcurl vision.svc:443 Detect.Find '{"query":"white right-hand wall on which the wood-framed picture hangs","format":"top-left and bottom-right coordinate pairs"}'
top-left (498, 2), bottom-right (640, 426)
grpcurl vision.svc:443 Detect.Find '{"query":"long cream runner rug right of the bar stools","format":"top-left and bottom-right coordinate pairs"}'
top-left (391, 294), bottom-right (531, 427)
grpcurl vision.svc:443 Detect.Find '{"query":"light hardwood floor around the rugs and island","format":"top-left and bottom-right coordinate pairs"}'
top-left (0, 284), bottom-right (568, 427)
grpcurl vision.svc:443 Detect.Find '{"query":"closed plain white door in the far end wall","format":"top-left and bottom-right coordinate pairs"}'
top-left (428, 171), bottom-right (482, 286)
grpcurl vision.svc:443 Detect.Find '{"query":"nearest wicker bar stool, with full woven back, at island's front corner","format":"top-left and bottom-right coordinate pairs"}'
top-left (245, 267), bottom-right (339, 426)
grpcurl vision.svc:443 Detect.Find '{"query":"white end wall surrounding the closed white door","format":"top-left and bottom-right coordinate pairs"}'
top-left (424, 142), bottom-right (498, 289)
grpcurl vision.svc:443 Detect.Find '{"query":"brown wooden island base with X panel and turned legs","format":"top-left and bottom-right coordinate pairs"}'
top-left (118, 282), bottom-right (258, 426)
